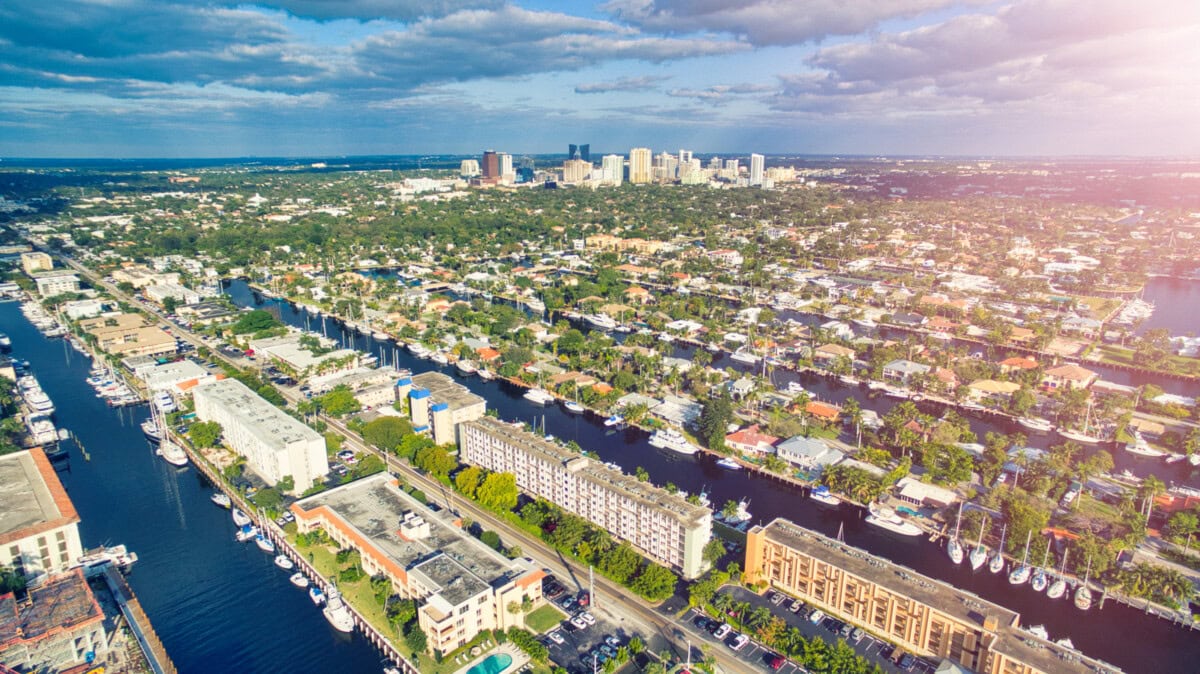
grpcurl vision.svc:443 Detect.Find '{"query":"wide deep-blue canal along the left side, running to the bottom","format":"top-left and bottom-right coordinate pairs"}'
top-left (0, 302), bottom-right (380, 674)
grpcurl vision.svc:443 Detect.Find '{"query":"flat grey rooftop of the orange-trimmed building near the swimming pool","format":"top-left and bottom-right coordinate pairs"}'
top-left (292, 473), bottom-right (527, 606)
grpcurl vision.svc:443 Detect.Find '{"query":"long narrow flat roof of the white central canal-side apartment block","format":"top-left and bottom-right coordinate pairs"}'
top-left (468, 416), bottom-right (712, 524)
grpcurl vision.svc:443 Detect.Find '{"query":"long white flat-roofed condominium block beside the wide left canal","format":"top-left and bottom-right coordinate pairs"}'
top-left (192, 379), bottom-right (329, 493)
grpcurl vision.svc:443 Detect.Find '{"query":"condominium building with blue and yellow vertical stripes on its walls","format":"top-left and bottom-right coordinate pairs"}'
top-left (396, 372), bottom-right (487, 445)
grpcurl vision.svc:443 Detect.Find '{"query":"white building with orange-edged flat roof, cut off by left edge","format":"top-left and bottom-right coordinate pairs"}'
top-left (0, 447), bottom-right (83, 578)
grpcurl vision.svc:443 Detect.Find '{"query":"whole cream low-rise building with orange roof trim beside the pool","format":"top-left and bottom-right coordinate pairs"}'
top-left (292, 473), bottom-right (545, 652)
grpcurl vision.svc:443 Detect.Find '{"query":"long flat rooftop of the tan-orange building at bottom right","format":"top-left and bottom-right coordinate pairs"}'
top-left (758, 518), bottom-right (1120, 673)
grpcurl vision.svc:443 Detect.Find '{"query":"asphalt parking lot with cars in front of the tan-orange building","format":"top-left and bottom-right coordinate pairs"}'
top-left (686, 586), bottom-right (937, 674)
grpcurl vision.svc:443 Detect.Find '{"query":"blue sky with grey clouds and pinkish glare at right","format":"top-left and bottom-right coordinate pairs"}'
top-left (0, 0), bottom-right (1200, 157)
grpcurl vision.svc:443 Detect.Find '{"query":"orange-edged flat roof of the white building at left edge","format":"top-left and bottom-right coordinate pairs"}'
top-left (0, 447), bottom-right (79, 544)
